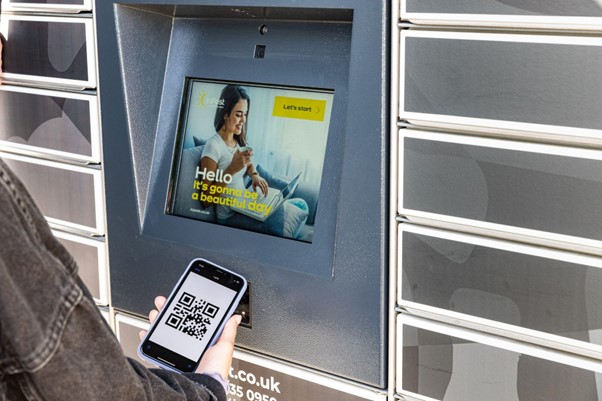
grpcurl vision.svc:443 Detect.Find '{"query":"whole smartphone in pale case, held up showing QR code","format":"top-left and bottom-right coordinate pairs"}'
top-left (138, 259), bottom-right (247, 373)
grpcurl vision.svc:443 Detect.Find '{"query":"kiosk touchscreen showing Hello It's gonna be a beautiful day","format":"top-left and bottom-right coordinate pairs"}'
top-left (167, 78), bottom-right (334, 242)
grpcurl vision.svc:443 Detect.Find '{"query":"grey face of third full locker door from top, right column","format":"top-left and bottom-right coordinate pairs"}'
top-left (400, 232), bottom-right (602, 345)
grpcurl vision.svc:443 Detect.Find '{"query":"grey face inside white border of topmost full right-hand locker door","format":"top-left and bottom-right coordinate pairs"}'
top-left (402, 34), bottom-right (602, 129)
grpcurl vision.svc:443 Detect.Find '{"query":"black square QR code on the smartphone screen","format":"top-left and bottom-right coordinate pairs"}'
top-left (165, 292), bottom-right (219, 340)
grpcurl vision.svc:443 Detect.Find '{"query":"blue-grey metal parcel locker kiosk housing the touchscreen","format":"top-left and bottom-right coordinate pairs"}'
top-left (95, 0), bottom-right (390, 388)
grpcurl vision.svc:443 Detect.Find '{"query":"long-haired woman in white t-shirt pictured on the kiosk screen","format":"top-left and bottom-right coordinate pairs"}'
top-left (198, 85), bottom-right (308, 238)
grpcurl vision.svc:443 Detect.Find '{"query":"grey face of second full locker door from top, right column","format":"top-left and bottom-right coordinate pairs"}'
top-left (403, 138), bottom-right (602, 240)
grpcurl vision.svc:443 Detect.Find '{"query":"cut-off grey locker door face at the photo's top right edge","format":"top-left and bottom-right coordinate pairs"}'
top-left (406, 0), bottom-right (602, 17)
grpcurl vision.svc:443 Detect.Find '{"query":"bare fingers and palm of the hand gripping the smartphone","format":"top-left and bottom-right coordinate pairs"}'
top-left (139, 296), bottom-right (242, 380)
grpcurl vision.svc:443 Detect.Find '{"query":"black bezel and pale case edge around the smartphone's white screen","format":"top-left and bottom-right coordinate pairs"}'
top-left (140, 259), bottom-right (245, 373)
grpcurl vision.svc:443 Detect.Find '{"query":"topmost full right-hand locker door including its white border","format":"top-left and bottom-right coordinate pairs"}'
top-left (399, 30), bottom-right (602, 143)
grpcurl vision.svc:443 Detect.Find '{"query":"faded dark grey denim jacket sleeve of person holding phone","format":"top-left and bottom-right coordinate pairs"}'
top-left (0, 160), bottom-right (226, 401)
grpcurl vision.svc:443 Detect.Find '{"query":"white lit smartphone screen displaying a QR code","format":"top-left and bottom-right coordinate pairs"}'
top-left (149, 271), bottom-right (236, 361)
